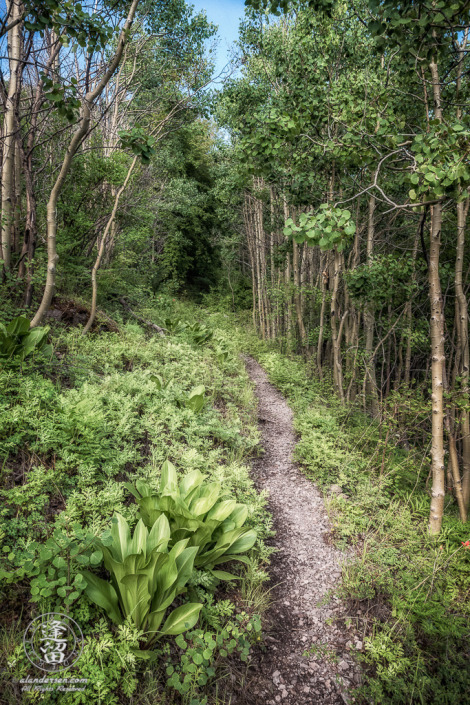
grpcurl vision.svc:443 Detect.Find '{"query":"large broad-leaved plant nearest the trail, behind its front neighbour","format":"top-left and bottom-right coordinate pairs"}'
top-left (126, 461), bottom-right (257, 580)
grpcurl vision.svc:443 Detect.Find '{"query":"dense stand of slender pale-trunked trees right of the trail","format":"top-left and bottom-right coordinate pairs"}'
top-left (218, 0), bottom-right (470, 535)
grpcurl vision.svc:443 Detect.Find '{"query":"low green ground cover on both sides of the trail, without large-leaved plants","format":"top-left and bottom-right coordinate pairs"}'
top-left (0, 297), bottom-right (470, 705)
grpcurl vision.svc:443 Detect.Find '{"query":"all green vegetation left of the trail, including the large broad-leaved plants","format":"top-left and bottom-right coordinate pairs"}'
top-left (0, 297), bottom-right (271, 704)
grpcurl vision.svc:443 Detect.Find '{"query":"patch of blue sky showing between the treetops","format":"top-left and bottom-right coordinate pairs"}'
top-left (189, 0), bottom-right (245, 80)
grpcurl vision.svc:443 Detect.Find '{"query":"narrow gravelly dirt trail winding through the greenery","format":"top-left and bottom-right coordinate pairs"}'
top-left (241, 358), bottom-right (362, 705)
